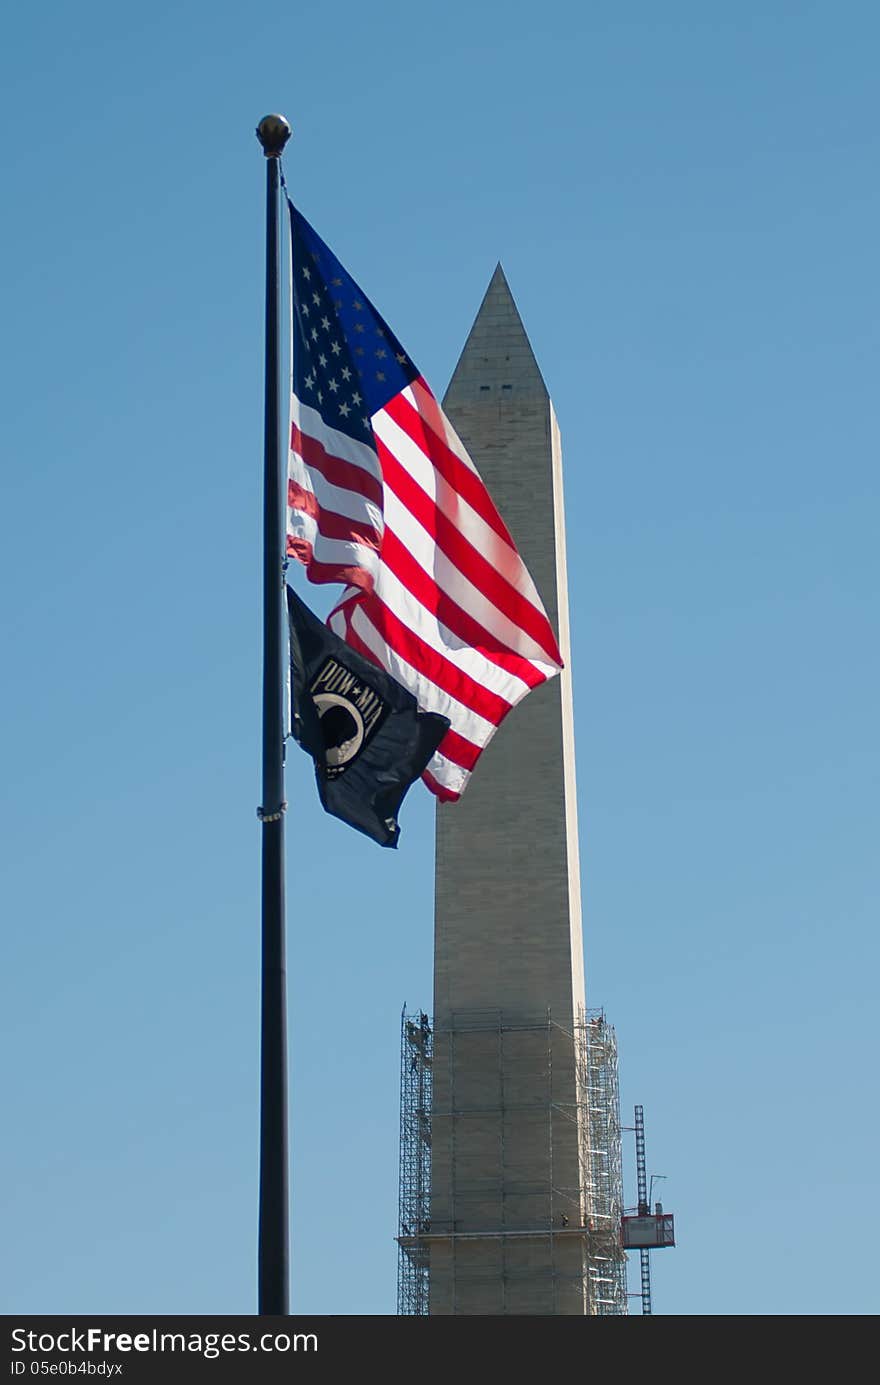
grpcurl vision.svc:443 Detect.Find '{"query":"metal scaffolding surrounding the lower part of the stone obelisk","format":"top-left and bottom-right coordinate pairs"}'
top-left (398, 1008), bottom-right (628, 1316)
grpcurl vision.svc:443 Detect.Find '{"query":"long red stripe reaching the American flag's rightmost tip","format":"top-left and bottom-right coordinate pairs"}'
top-left (376, 436), bottom-right (561, 663)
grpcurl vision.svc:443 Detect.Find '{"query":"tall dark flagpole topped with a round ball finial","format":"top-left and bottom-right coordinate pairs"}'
top-left (256, 115), bottom-right (291, 1316)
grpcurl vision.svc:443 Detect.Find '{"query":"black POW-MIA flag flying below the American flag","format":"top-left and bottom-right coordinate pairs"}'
top-left (287, 587), bottom-right (449, 846)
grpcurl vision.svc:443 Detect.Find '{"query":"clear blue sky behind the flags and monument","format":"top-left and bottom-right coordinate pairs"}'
top-left (0, 0), bottom-right (880, 1314)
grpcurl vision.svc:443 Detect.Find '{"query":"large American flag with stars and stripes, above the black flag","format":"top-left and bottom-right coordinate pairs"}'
top-left (287, 204), bottom-right (563, 799)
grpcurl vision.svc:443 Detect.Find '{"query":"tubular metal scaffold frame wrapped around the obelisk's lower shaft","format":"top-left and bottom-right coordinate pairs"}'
top-left (398, 1008), bottom-right (628, 1316)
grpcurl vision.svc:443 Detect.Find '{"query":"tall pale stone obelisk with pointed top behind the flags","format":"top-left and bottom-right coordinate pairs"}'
top-left (428, 265), bottom-right (589, 1314)
